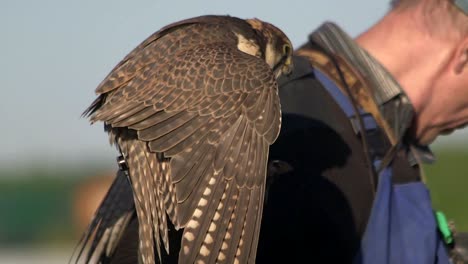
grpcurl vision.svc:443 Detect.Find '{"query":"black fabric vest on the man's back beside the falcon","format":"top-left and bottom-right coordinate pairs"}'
top-left (257, 55), bottom-right (419, 263)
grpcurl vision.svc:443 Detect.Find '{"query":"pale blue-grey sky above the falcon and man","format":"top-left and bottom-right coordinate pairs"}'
top-left (0, 0), bottom-right (468, 166)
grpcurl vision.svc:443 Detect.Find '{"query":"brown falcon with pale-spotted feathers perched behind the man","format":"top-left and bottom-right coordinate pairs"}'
top-left (79, 16), bottom-right (292, 263)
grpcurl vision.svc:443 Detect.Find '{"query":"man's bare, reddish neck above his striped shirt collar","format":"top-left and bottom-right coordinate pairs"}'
top-left (356, 9), bottom-right (458, 138)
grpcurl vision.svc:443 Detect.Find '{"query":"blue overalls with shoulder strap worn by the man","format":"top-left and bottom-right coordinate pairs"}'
top-left (314, 69), bottom-right (450, 264)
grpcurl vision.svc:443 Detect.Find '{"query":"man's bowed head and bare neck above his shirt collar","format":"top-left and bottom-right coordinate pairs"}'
top-left (358, 0), bottom-right (468, 144)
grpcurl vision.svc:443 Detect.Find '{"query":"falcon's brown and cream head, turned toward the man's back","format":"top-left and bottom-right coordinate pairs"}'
top-left (246, 18), bottom-right (293, 78)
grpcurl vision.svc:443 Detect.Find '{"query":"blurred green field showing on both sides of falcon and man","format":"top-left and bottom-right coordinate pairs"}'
top-left (0, 150), bottom-right (468, 247)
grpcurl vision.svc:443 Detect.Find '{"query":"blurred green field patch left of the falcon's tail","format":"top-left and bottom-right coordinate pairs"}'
top-left (0, 168), bottom-right (102, 245)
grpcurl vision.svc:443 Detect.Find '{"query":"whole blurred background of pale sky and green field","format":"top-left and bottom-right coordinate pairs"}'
top-left (0, 0), bottom-right (468, 263)
